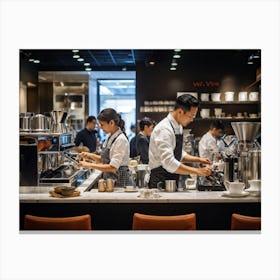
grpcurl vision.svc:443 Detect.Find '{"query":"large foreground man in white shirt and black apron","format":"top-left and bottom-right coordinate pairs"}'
top-left (149, 94), bottom-right (212, 188)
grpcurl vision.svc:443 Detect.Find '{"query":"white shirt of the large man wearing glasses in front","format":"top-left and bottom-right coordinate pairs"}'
top-left (149, 113), bottom-right (187, 173)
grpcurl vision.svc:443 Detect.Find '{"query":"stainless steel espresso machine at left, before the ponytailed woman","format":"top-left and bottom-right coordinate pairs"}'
top-left (20, 110), bottom-right (89, 187)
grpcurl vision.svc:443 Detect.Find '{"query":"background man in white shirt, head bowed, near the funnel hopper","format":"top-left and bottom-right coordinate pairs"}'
top-left (198, 120), bottom-right (225, 160)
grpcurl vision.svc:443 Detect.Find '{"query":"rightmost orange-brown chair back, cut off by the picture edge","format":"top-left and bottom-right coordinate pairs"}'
top-left (231, 213), bottom-right (261, 230)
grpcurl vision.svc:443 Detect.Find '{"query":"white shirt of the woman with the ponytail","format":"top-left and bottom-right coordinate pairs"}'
top-left (103, 130), bottom-right (129, 169)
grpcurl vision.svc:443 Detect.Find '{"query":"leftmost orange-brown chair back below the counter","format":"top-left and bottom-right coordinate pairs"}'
top-left (24, 214), bottom-right (92, 230)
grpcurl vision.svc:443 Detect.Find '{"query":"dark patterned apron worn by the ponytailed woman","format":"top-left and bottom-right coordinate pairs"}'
top-left (100, 130), bottom-right (135, 187)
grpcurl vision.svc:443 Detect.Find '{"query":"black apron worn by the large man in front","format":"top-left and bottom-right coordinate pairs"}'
top-left (149, 121), bottom-right (183, 188)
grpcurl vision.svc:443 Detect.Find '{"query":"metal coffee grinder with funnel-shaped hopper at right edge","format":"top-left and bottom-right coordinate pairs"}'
top-left (231, 122), bottom-right (261, 188)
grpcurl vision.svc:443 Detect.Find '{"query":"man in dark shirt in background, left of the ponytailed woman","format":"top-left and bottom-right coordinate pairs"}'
top-left (75, 116), bottom-right (96, 153)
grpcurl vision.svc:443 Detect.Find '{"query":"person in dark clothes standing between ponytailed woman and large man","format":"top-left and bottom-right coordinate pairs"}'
top-left (135, 118), bottom-right (154, 164)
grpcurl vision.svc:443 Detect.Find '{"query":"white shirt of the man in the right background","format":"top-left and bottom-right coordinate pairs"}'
top-left (198, 131), bottom-right (219, 160)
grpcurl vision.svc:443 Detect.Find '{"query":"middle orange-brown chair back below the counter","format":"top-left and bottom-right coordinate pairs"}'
top-left (132, 213), bottom-right (196, 230)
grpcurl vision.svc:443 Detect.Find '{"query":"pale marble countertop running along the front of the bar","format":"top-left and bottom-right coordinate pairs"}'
top-left (19, 171), bottom-right (261, 203)
